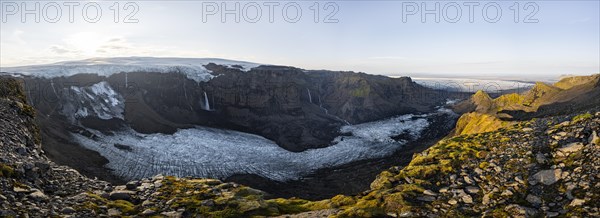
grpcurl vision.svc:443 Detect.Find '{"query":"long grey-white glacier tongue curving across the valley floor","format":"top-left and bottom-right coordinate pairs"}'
top-left (73, 112), bottom-right (436, 181)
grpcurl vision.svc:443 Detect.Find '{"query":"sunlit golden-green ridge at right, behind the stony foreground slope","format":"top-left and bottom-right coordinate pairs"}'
top-left (454, 74), bottom-right (600, 135)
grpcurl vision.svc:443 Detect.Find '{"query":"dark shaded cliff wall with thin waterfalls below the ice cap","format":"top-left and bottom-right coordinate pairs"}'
top-left (19, 64), bottom-right (452, 151)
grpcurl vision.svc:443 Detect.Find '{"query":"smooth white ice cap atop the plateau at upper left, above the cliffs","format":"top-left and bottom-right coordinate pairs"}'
top-left (0, 57), bottom-right (259, 82)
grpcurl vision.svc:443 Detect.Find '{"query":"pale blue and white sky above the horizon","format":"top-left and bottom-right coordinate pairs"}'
top-left (0, 0), bottom-right (600, 79)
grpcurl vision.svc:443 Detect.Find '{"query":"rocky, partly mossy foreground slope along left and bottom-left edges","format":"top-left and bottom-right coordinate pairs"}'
top-left (0, 78), bottom-right (312, 217)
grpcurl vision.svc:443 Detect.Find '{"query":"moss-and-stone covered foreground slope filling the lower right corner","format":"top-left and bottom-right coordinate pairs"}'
top-left (332, 109), bottom-right (600, 217)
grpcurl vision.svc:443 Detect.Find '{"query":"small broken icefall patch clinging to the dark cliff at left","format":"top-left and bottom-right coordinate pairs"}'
top-left (61, 82), bottom-right (125, 122)
